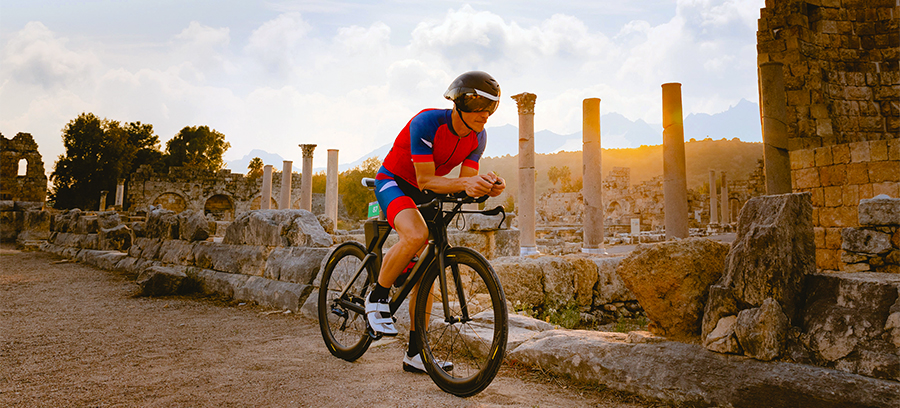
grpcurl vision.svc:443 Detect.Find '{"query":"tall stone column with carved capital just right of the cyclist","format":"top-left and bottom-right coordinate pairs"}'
top-left (512, 92), bottom-right (538, 255)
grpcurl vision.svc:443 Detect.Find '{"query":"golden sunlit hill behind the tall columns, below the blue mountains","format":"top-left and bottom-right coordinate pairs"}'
top-left (480, 139), bottom-right (763, 200)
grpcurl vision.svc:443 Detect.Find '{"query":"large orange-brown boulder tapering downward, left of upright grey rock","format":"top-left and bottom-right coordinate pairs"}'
top-left (616, 237), bottom-right (732, 339)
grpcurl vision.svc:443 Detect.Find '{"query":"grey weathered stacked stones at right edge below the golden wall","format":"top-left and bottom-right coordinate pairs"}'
top-left (841, 196), bottom-right (900, 273)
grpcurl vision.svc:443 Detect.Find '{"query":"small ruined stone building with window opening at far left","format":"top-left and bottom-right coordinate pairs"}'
top-left (0, 133), bottom-right (47, 202)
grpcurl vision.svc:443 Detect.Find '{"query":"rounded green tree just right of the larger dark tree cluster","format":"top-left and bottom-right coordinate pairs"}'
top-left (166, 126), bottom-right (231, 171)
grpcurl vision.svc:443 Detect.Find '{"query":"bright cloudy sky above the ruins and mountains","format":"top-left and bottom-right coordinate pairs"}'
top-left (0, 0), bottom-right (764, 173)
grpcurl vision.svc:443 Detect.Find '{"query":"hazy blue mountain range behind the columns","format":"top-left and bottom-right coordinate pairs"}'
top-left (227, 99), bottom-right (762, 173)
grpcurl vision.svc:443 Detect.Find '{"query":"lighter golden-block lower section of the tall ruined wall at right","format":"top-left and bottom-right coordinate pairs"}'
top-left (791, 139), bottom-right (900, 271)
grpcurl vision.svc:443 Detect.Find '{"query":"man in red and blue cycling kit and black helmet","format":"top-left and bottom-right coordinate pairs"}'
top-left (366, 71), bottom-right (506, 372)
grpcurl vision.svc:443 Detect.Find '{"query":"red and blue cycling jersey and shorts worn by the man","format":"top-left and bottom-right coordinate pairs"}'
top-left (375, 109), bottom-right (487, 225)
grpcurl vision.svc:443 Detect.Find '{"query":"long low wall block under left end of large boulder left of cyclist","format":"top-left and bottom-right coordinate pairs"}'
top-left (194, 242), bottom-right (269, 276)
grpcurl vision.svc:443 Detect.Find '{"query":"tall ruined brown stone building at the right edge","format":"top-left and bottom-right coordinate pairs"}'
top-left (757, 0), bottom-right (900, 270)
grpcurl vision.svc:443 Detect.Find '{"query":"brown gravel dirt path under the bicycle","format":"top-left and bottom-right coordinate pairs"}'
top-left (0, 245), bottom-right (652, 407)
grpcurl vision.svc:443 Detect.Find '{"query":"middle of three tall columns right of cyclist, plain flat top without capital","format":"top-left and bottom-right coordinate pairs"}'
top-left (581, 98), bottom-right (606, 254)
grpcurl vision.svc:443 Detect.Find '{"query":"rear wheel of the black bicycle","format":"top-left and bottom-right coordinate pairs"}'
top-left (318, 242), bottom-right (372, 361)
